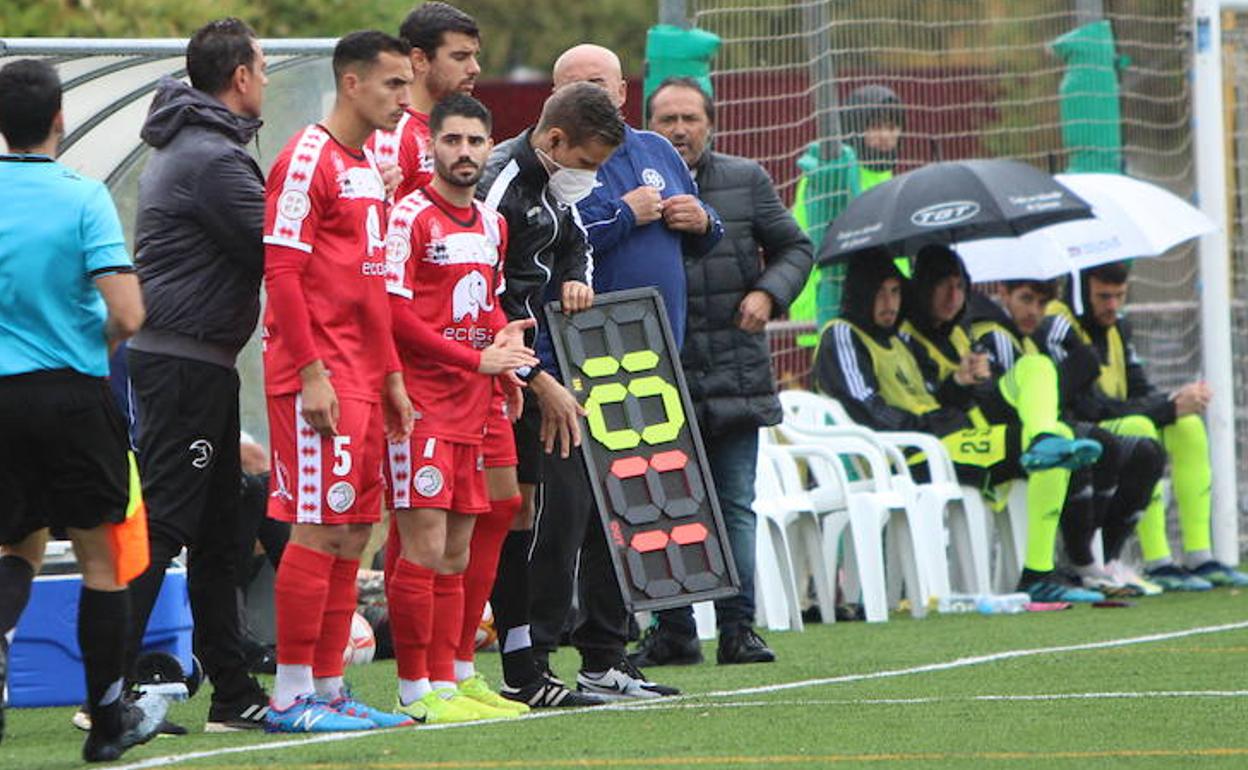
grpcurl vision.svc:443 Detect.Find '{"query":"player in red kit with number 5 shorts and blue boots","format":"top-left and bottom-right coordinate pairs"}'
top-left (263, 31), bottom-right (412, 733)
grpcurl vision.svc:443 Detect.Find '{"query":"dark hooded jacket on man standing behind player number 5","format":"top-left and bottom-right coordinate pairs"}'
top-left (130, 77), bottom-right (265, 367)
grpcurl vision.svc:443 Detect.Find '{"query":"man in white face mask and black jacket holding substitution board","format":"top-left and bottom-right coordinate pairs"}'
top-left (477, 84), bottom-right (624, 708)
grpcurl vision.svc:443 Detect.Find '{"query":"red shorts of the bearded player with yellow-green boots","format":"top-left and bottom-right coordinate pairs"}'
top-left (386, 433), bottom-right (489, 514)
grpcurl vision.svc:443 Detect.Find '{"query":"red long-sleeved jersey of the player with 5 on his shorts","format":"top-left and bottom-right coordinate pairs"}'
top-left (263, 125), bottom-right (391, 403)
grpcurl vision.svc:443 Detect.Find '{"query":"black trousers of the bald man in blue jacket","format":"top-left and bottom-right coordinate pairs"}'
top-left (529, 449), bottom-right (628, 671)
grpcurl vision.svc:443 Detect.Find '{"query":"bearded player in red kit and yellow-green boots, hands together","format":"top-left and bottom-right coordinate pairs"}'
top-left (386, 94), bottom-right (535, 723)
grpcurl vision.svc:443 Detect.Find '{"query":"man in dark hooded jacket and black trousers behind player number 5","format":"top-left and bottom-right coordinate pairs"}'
top-left (129, 19), bottom-right (268, 733)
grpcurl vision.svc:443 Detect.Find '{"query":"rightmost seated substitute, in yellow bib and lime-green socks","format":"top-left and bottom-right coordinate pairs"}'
top-left (1048, 262), bottom-right (1248, 590)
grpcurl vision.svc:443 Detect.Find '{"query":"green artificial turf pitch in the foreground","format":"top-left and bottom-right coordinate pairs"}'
top-left (0, 590), bottom-right (1248, 770)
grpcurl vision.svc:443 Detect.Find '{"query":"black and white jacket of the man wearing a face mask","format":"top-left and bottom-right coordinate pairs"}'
top-left (477, 129), bottom-right (593, 322)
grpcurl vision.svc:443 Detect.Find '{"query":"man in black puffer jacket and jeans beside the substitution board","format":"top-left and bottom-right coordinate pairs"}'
top-left (633, 77), bottom-right (812, 666)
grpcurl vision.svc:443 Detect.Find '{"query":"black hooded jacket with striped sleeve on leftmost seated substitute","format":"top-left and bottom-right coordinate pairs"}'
top-left (815, 255), bottom-right (971, 436)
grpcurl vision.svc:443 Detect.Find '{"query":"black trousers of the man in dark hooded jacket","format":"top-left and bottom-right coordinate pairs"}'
top-left (127, 349), bottom-right (255, 703)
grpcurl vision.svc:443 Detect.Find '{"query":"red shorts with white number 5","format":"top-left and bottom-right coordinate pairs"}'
top-left (267, 393), bottom-right (386, 524)
